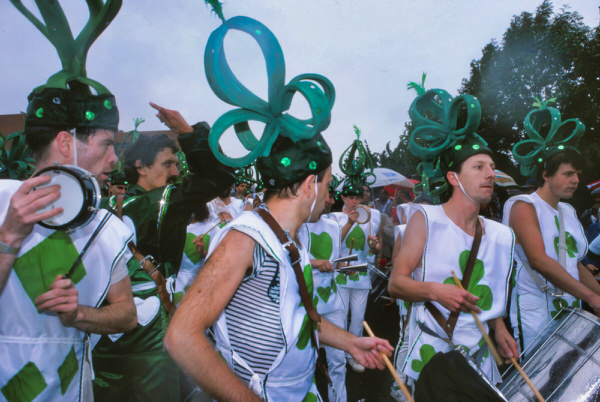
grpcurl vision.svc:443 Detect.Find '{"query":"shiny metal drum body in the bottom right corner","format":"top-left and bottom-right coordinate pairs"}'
top-left (500, 308), bottom-right (600, 402)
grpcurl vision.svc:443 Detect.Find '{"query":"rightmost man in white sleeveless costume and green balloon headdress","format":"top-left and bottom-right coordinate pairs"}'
top-left (503, 100), bottom-right (600, 350)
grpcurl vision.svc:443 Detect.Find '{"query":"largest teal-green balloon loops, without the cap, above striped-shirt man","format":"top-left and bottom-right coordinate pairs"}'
top-left (204, 17), bottom-right (335, 167)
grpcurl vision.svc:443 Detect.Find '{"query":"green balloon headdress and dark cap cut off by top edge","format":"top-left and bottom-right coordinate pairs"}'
top-left (11, 0), bottom-right (122, 131)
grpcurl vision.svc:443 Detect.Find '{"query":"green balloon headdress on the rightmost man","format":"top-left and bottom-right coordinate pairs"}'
top-left (513, 98), bottom-right (585, 177)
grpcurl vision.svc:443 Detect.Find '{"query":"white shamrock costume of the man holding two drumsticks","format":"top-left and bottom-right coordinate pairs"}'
top-left (403, 205), bottom-right (514, 382)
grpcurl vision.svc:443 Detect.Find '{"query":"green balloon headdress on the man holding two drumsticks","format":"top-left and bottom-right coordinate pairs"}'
top-left (408, 75), bottom-right (492, 177)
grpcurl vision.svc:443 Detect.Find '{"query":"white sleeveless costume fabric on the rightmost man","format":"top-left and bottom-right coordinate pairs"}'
top-left (503, 193), bottom-right (587, 348)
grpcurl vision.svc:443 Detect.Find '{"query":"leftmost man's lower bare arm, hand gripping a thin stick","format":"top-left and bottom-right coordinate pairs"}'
top-left (35, 275), bottom-right (137, 334)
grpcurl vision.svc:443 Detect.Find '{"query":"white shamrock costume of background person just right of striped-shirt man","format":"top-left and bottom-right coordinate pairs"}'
top-left (298, 216), bottom-right (344, 314)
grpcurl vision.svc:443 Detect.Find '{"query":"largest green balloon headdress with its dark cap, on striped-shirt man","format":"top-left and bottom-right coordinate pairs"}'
top-left (204, 17), bottom-right (335, 188)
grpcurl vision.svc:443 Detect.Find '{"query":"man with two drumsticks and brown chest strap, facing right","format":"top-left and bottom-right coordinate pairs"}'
top-left (389, 82), bottom-right (517, 400)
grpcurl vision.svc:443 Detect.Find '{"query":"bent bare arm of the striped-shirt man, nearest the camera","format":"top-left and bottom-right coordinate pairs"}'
top-left (164, 230), bottom-right (260, 401)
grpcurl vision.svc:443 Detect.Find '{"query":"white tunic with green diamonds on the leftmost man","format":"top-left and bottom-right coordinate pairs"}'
top-left (0, 180), bottom-right (132, 401)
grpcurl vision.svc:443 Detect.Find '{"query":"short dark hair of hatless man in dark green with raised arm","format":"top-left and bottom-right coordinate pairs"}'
top-left (123, 133), bottom-right (179, 183)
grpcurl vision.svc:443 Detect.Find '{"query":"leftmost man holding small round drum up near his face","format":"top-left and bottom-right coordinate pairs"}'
top-left (0, 0), bottom-right (136, 401)
